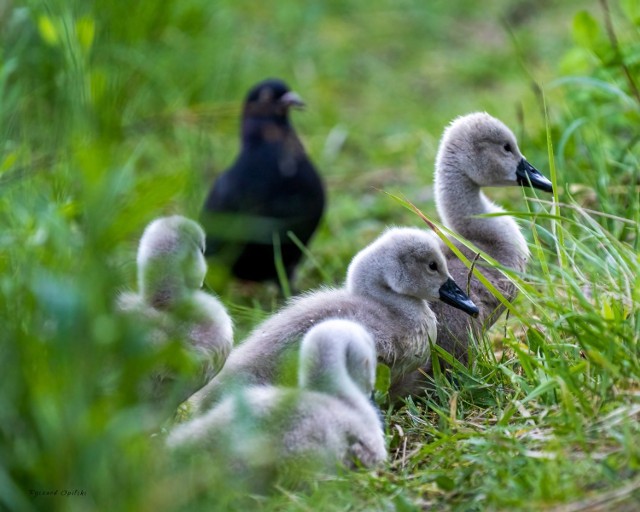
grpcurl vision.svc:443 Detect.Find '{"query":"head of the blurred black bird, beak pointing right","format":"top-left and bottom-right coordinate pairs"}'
top-left (244, 78), bottom-right (304, 122)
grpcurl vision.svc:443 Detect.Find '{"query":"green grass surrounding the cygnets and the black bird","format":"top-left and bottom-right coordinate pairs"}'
top-left (0, 0), bottom-right (640, 511)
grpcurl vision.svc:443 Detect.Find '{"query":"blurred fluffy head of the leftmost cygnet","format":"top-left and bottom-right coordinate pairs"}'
top-left (137, 215), bottom-right (207, 306)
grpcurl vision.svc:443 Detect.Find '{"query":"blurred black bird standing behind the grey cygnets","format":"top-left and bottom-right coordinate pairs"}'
top-left (201, 79), bottom-right (325, 284)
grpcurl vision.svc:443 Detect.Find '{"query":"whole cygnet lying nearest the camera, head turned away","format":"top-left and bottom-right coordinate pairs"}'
top-left (167, 320), bottom-right (387, 488)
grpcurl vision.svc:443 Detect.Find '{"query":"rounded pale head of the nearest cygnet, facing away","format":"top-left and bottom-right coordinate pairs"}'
top-left (299, 319), bottom-right (376, 396)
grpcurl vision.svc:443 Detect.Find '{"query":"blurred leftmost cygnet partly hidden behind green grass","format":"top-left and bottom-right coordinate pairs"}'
top-left (117, 215), bottom-right (233, 400)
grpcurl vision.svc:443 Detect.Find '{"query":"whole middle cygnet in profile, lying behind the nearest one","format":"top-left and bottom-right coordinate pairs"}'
top-left (189, 227), bottom-right (478, 410)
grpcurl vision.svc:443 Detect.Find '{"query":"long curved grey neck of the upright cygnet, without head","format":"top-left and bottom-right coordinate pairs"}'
top-left (435, 164), bottom-right (529, 270)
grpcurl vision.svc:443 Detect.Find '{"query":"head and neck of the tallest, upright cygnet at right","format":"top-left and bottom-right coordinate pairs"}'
top-left (435, 112), bottom-right (553, 264)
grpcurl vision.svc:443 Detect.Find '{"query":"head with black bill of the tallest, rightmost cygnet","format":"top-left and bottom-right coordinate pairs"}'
top-left (436, 112), bottom-right (553, 192)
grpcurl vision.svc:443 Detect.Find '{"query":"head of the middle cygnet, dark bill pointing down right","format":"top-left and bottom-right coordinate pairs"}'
top-left (347, 227), bottom-right (478, 315)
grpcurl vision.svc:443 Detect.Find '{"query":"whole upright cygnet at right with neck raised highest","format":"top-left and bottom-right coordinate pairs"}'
top-left (395, 112), bottom-right (553, 396)
